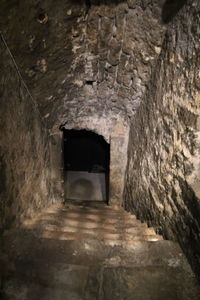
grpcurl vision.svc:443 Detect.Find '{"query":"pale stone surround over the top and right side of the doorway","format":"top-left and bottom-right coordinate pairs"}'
top-left (60, 116), bottom-right (129, 206)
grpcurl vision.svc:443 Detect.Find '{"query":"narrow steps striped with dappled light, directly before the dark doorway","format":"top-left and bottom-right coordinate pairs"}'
top-left (25, 204), bottom-right (163, 248)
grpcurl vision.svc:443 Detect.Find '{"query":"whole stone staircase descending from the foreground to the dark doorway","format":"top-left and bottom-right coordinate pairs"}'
top-left (2, 202), bottom-right (200, 300)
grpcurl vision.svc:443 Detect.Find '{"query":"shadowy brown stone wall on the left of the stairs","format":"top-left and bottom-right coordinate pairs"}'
top-left (0, 39), bottom-right (57, 231)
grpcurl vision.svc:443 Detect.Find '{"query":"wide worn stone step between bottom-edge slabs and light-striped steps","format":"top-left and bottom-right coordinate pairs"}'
top-left (3, 230), bottom-right (188, 269)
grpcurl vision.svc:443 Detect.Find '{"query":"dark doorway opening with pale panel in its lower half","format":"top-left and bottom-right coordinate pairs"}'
top-left (63, 129), bottom-right (110, 202)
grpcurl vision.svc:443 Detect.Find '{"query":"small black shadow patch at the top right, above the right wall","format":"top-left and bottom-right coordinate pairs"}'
top-left (162, 0), bottom-right (187, 24)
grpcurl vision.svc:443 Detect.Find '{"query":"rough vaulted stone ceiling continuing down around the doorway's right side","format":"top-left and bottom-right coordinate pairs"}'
top-left (0, 0), bottom-right (165, 204)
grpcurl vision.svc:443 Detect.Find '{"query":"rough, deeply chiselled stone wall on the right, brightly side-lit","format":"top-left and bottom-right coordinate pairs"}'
top-left (124, 1), bottom-right (200, 275)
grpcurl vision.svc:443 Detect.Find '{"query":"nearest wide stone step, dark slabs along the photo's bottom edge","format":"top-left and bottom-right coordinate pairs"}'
top-left (5, 260), bottom-right (199, 300)
